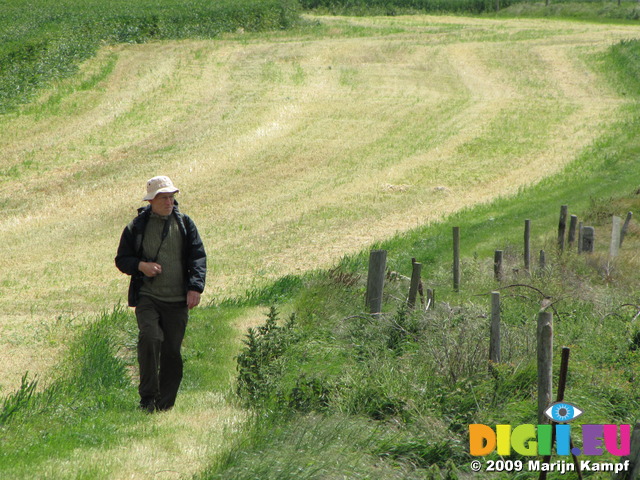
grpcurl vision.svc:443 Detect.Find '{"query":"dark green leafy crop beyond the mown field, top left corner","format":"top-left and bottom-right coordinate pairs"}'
top-left (0, 0), bottom-right (299, 113)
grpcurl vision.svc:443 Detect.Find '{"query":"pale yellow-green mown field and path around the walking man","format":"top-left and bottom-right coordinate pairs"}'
top-left (0, 6), bottom-right (637, 478)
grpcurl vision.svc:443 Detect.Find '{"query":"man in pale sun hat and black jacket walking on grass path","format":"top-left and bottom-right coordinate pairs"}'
top-left (115, 176), bottom-right (207, 412)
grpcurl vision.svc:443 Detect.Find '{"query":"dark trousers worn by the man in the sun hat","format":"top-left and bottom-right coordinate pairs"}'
top-left (136, 296), bottom-right (189, 410)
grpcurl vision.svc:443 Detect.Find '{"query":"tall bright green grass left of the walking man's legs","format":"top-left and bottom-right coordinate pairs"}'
top-left (0, 308), bottom-right (144, 478)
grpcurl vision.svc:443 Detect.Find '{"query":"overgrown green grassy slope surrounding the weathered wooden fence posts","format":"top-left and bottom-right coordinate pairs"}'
top-left (202, 35), bottom-right (640, 479)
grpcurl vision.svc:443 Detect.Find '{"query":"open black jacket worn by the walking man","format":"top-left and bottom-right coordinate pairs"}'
top-left (115, 202), bottom-right (207, 307)
